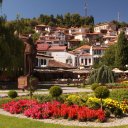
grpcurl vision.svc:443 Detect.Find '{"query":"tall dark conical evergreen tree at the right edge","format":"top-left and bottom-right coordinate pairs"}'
top-left (115, 31), bottom-right (128, 70)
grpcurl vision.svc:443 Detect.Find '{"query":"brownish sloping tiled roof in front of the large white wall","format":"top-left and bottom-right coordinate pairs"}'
top-left (48, 60), bottom-right (73, 68)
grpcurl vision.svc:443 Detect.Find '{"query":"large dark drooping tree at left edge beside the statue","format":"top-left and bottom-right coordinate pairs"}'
top-left (0, 17), bottom-right (24, 80)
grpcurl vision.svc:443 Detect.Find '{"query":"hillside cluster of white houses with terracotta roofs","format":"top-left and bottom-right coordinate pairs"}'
top-left (17, 22), bottom-right (128, 81)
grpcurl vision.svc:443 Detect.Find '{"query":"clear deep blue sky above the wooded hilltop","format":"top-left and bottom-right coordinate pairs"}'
top-left (0, 0), bottom-right (128, 23)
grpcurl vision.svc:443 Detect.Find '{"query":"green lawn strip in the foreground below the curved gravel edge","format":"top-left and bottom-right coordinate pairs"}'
top-left (0, 115), bottom-right (128, 128)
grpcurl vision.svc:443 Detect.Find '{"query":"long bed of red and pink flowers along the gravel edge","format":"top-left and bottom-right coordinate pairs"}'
top-left (3, 100), bottom-right (105, 122)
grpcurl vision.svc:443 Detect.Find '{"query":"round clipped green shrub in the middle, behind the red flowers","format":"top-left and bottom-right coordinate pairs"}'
top-left (49, 86), bottom-right (62, 98)
